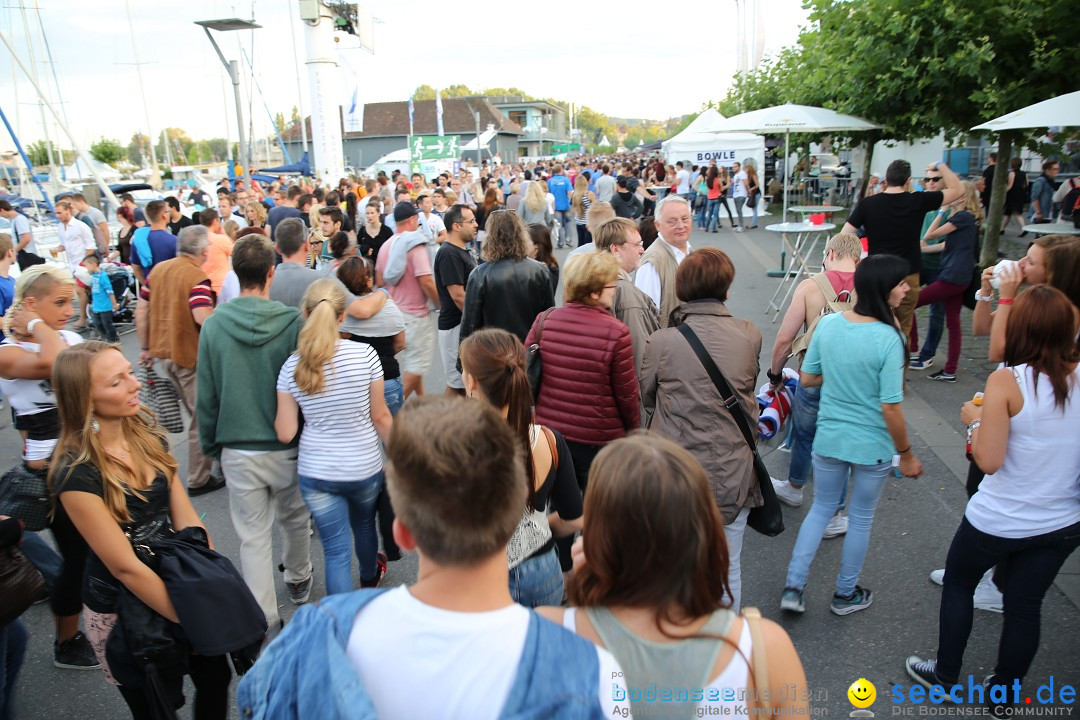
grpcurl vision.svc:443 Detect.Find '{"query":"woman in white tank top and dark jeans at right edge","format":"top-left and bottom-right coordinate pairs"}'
top-left (907, 285), bottom-right (1080, 711)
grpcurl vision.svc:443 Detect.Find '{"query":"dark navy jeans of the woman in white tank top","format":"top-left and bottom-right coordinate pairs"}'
top-left (937, 517), bottom-right (1080, 684)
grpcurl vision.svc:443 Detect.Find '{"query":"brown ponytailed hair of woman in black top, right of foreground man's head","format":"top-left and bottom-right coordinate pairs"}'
top-left (459, 327), bottom-right (537, 507)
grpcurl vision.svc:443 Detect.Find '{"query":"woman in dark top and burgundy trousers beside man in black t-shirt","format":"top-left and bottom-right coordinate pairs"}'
top-left (915, 182), bottom-right (983, 382)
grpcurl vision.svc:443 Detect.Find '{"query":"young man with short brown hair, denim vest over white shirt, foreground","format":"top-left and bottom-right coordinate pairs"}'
top-left (238, 397), bottom-right (629, 720)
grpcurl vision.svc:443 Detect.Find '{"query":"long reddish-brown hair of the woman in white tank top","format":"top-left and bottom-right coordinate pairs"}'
top-left (1004, 285), bottom-right (1077, 409)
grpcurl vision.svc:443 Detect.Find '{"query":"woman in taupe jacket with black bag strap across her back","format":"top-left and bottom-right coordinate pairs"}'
top-left (640, 247), bottom-right (768, 610)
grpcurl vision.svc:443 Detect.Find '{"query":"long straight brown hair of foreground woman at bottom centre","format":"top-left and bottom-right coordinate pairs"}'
top-left (567, 431), bottom-right (731, 628)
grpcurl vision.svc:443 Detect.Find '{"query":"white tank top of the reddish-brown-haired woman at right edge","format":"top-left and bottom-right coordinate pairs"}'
top-left (964, 364), bottom-right (1080, 539)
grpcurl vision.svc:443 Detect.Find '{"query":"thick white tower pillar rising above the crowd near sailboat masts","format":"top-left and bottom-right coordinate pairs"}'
top-left (303, 2), bottom-right (345, 184)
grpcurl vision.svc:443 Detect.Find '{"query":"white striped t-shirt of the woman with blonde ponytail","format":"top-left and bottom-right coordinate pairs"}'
top-left (278, 340), bottom-right (382, 481)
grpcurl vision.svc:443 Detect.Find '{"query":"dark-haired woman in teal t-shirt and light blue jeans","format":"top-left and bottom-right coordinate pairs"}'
top-left (780, 255), bottom-right (922, 615)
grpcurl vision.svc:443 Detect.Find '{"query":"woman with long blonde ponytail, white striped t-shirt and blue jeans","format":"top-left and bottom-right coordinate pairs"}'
top-left (274, 279), bottom-right (391, 594)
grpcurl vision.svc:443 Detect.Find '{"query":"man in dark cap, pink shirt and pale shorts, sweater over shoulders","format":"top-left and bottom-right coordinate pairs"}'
top-left (375, 202), bottom-right (438, 399)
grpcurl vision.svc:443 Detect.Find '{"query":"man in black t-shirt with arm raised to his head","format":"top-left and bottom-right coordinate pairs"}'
top-left (841, 160), bottom-right (963, 337)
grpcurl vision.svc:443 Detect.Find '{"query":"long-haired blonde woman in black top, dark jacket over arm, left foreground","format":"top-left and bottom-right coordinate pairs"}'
top-left (49, 340), bottom-right (231, 719)
